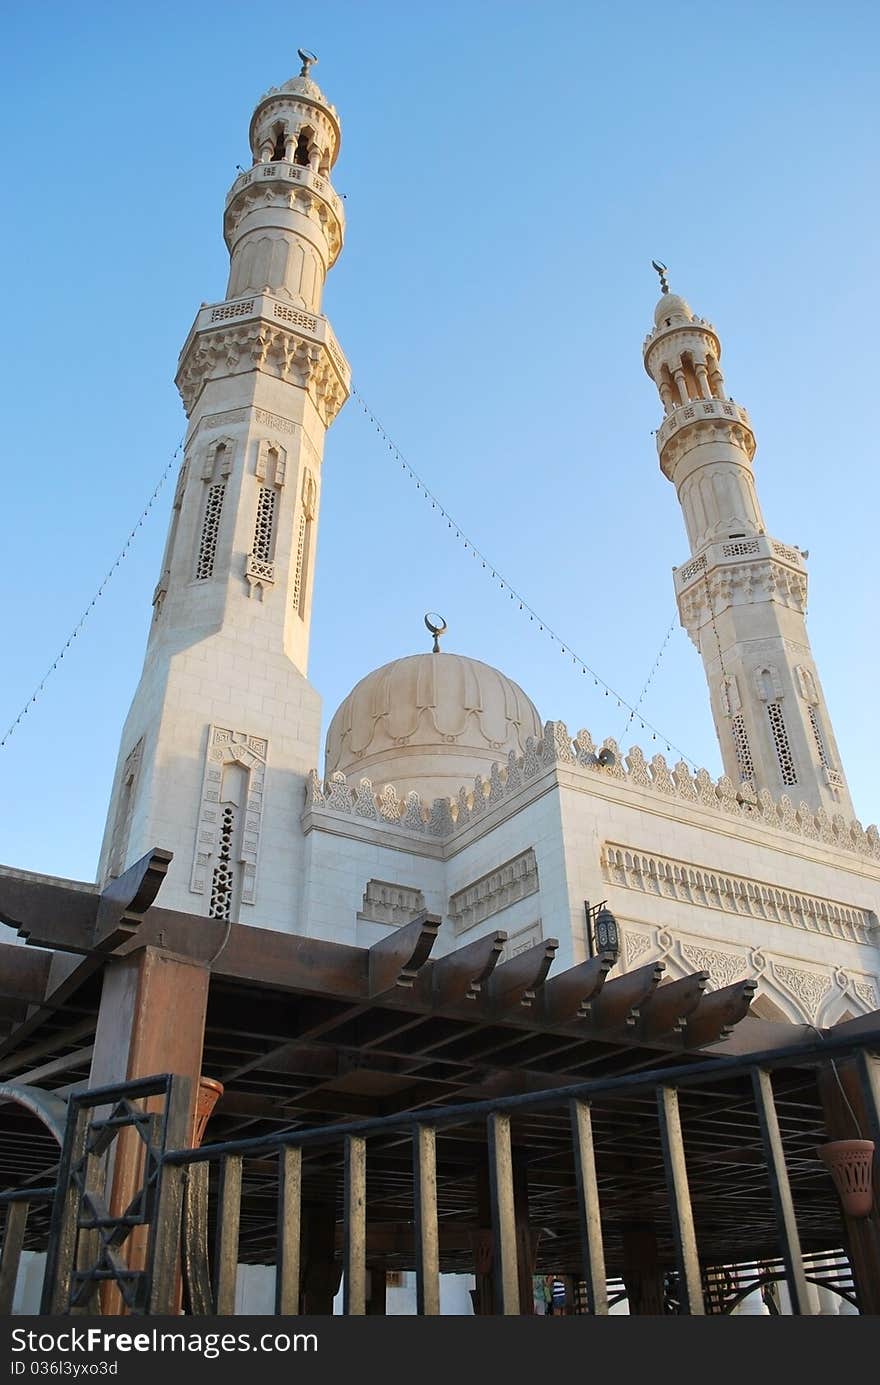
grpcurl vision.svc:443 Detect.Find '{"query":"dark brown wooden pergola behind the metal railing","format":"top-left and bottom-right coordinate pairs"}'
top-left (0, 850), bottom-right (880, 1312)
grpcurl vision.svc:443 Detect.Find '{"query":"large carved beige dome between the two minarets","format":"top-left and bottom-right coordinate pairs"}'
top-left (324, 652), bottom-right (542, 803)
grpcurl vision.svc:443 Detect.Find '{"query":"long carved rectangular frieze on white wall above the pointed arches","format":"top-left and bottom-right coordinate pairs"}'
top-left (600, 842), bottom-right (877, 945)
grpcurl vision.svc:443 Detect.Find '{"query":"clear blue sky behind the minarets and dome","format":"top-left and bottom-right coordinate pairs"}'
top-left (0, 0), bottom-right (880, 879)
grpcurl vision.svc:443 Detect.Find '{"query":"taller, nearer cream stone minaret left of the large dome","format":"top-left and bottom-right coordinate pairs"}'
top-left (98, 50), bottom-right (349, 929)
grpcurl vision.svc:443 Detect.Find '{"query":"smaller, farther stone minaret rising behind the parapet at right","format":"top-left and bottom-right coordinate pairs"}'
top-left (644, 265), bottom-right (854, 819)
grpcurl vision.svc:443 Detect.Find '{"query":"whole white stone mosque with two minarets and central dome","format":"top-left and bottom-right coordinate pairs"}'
top-left (0, 54), bottom-right (880, 1307)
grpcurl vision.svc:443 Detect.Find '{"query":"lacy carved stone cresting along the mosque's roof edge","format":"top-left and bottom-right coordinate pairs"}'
top-left (305, 722), bottom-right (880, 861)
